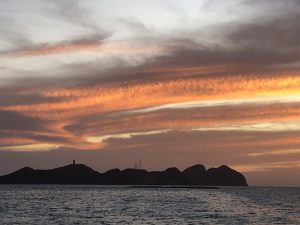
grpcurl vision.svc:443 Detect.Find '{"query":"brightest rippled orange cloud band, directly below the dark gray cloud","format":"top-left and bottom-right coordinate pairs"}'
top-left (2, 74), bottom-right (300, 118)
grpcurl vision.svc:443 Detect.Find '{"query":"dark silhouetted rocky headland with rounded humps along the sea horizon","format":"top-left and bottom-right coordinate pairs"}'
top-left (0, 164), bottom-right (248, 187)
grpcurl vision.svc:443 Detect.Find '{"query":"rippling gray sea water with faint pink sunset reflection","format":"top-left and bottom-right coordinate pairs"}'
top-left (0, 185), bottom-right (300, 225)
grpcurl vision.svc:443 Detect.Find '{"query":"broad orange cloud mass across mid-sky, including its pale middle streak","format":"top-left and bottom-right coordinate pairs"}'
top-left (0, 73), bottom-right (300, 148)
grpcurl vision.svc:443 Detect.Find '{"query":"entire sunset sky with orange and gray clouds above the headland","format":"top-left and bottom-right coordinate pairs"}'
top-left (0, 0), bottom-right (300, 186)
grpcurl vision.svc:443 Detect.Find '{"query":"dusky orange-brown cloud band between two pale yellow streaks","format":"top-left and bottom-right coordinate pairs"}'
top-left (65, 104), bottom-right (299, 136)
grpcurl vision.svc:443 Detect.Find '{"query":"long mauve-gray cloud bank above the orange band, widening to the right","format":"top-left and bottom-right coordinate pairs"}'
top-left (22, 2), bottom-right (300, 85)
